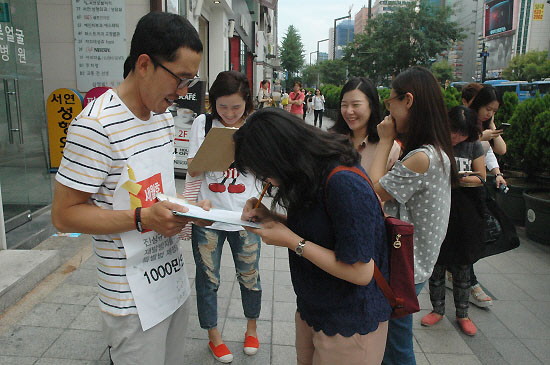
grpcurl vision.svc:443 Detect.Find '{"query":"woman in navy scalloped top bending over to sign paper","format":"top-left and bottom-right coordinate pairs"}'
top-left (234, 108), bottom-right (391, 365)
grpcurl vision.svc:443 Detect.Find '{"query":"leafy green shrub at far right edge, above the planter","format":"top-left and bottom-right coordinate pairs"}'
top-left (503, 95), bottom-right (550, 175)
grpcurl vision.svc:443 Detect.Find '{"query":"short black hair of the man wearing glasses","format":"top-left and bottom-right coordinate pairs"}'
top-left (123, 12), bottom-right (202, 78)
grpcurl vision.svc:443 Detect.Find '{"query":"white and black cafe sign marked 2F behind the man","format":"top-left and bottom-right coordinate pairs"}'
top-left (174, 81), bottom-right (206, 173)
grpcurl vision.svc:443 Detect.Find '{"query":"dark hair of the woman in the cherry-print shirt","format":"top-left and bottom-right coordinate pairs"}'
top-left (208, 71), bottom-right (254, 120)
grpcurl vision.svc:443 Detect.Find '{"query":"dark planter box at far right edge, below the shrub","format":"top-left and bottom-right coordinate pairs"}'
top-left (523, 189), bottom-right (550, 245)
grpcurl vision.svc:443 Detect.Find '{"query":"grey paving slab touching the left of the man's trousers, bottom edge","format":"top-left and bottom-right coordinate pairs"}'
top-left (44, 329), bottom-right (107, 360)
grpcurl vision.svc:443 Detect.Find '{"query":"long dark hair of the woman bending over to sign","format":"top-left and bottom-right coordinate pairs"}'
top-left (233, 108), bottom-right (360, 209)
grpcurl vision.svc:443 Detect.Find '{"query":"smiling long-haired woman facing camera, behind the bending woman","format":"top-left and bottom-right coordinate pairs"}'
top-left (330, 77), bottom-right (401, 171)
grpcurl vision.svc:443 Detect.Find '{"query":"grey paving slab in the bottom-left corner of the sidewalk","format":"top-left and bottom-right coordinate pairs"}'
top-left (0, 326), bottom-right (63, 357)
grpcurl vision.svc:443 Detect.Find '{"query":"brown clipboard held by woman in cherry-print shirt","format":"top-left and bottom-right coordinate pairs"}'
top-left (187, 127), bottom-right (238, 173)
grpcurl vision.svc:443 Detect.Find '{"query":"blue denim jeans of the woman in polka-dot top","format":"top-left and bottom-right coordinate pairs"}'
top-left (382, 282), bottom-right (426, 365)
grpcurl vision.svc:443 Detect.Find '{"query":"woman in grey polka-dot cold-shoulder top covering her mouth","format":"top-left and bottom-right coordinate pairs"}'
top-left (369, 66), bottom-right (458, 365)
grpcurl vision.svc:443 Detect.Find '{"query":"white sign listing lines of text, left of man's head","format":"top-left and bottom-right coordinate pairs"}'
top-left (72, 0), bottom-right (126, 91)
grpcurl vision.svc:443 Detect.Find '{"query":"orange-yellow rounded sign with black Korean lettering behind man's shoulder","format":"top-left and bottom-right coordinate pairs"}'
top-left (46, 89), bottom-right (82, 170)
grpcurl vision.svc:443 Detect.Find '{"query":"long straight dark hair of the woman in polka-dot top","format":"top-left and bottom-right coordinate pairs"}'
top-left (392, 66), bottom-right (458, 184)
